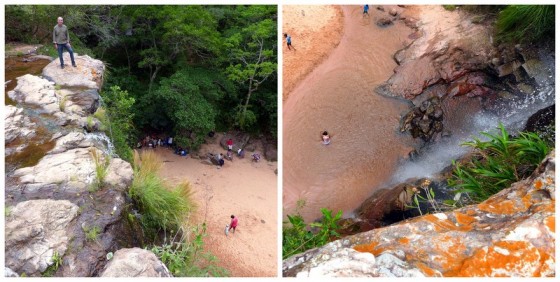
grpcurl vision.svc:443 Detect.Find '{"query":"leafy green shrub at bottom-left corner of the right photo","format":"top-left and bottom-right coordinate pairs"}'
top-left (282, 208), bottom-right (342, 259)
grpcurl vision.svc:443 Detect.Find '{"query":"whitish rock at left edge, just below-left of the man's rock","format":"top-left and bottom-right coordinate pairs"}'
top-left (8, 74), bottom-right (60, 114)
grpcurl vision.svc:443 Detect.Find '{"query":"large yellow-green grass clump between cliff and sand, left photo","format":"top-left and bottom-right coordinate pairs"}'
top-left (129, 151), bottom-right (195, 234)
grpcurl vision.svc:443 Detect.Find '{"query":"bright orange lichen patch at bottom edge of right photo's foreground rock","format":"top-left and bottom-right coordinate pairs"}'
top-left (456, 241), bottom-right (542, 277)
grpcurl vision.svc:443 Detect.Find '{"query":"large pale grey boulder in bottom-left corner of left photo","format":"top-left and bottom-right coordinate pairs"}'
top-left (6, 200), bottom-right (78, 276)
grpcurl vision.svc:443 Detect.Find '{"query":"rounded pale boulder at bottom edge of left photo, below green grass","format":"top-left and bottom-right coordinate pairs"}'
top-left (100, 248), bottom-right (173, 277)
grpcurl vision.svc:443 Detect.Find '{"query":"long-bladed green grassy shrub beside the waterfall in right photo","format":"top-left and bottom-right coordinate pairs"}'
top-left (448, 124), bottom-right (551, 202)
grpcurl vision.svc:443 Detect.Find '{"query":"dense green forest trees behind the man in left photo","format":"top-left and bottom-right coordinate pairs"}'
top-left (5, 5), bottom-right (278, 150)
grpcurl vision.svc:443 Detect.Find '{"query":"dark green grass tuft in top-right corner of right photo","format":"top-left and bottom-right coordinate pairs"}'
top-left (497, 5), bottom-right (555, 42)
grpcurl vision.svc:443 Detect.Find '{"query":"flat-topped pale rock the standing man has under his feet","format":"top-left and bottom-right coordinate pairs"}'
top-left (43, 53), bottom-right (105, 89)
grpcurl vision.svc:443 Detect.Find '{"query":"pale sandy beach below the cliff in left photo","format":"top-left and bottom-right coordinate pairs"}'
top-left (156, 136), bottom-right (278, 277)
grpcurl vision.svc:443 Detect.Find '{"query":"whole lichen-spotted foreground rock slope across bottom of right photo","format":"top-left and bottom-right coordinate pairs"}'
top-left (283, 151), bottom-right (556, 277)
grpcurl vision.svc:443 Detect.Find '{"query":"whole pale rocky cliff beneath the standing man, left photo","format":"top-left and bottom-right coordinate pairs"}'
top-left (5, 56), bottom-right (162, 276)
